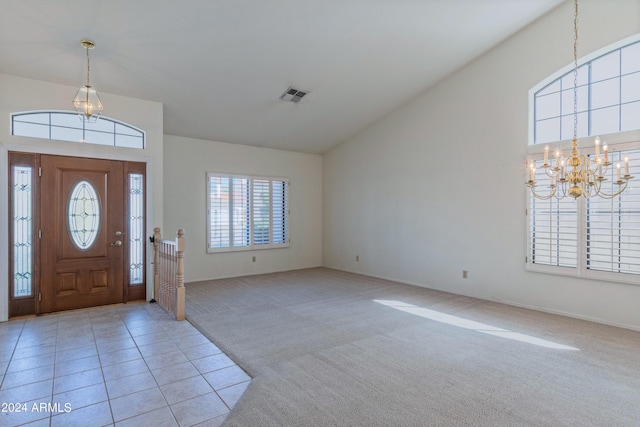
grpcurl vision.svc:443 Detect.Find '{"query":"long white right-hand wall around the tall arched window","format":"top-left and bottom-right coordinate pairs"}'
top-left (323, 0), bottom-right (640, 329)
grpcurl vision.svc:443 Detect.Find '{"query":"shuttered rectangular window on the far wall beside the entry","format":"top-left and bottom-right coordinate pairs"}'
top-left (207, 173), bottom-right (289, 252)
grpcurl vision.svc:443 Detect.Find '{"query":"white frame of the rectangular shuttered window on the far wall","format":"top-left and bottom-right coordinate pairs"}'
top-left (205, 172), bottom-right (291, 253)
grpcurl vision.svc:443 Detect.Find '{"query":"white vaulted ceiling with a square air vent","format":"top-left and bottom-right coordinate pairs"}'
top-left (0, 0), bottom-right (563, 153)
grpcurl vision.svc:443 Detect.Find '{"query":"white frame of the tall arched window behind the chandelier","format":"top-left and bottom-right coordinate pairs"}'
top-left (523, 34), bottom-right (640, 285)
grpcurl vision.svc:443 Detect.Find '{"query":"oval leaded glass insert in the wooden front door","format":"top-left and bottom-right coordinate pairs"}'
top-left (67, 181), bottom-right (100, 250)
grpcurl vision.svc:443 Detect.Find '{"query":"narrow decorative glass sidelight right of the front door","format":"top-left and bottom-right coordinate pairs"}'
top-left (129, 173), bottom-right (145, 285)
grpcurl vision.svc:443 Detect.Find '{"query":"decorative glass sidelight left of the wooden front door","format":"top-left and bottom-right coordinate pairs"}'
top-left (12, 166), bottom-right (33, 298)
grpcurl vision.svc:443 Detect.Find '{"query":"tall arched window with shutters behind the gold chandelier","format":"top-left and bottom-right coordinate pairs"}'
top-left (526, 34), bottom-right (640, 284)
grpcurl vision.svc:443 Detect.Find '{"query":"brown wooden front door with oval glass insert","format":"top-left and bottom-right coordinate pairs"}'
top-left (39, 155), bottom-right (125, 313)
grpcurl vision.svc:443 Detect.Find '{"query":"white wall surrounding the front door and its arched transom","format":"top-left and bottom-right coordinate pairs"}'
top-left (0, 74), bottom-right (163, 321)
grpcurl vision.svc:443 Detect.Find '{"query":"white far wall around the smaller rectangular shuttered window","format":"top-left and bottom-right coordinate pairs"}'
top-left (162, 135), bottom-right (322, 282)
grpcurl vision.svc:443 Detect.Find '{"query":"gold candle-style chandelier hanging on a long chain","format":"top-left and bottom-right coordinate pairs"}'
top-left (526, 0), bottom-right (633, 200)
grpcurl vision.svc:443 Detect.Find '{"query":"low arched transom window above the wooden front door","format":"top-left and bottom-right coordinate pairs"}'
top-left (11, 111), bottom-right (145, 149)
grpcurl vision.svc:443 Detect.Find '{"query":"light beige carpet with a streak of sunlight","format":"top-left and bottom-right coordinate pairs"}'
top-left (187, 268), bottom-right (640, 427)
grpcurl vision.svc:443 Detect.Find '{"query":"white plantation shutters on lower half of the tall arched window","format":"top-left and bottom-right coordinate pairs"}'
top-left (526, 143), bottom-right (640, 284)
